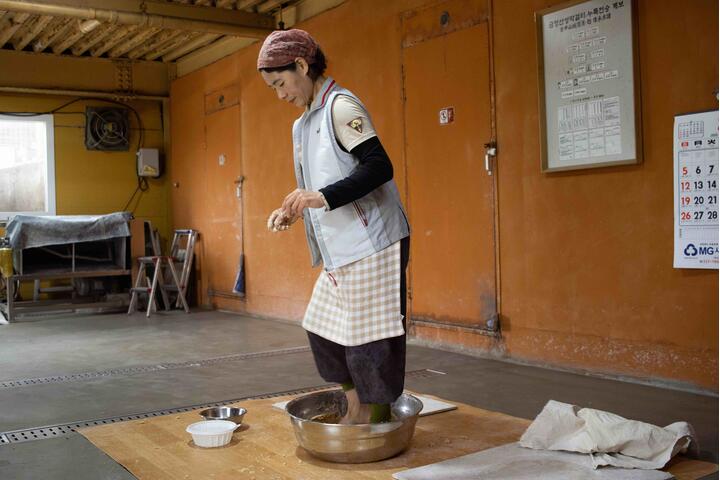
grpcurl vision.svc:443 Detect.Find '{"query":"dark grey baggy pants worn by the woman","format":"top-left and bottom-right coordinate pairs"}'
top-left (307, 237), bottom-right (410, 403)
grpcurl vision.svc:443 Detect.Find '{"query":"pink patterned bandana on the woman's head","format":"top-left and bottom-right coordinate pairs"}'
top-left (258, 28), bottom-right (318, 70)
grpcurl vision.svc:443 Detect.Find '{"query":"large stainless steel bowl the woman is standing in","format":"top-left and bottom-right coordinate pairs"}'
top-left (285, 390), bottom-right (423, 463)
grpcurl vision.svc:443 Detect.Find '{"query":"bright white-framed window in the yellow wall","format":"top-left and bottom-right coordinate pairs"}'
top-left (0, 115), bottom-right (55, 220)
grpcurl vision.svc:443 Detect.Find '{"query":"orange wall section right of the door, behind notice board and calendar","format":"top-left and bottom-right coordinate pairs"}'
top-left (494, 0), bottom-right (718, 390)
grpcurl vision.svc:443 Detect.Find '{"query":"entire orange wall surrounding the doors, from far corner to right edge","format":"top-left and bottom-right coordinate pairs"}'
top-left (171, 0), bottom-right (718, 389)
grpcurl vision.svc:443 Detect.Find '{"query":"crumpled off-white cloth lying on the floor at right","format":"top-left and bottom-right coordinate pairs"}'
top-left (520, 400), bottom-right (694, 469)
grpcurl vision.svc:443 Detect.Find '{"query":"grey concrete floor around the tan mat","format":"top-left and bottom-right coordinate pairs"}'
top-left (0, 312), bottom-right (718, 480)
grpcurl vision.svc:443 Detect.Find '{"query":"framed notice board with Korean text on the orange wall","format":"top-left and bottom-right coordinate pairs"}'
top-left (535, 0), bottom-right (642, 172)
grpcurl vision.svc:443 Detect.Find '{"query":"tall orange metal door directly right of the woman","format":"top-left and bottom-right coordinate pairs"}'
top-left (403, 2), bottom-right (497, 329)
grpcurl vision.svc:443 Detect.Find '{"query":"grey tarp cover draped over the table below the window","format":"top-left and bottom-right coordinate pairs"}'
top-left (5, 212), bottom-right (132, 249)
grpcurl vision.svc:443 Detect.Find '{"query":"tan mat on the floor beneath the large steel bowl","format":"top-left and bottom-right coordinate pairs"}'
top-left (79, 397), bottom-right (717, 480)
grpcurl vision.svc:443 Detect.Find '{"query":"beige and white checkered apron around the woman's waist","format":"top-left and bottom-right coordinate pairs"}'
top-left (302, 242), bottom-right (405, 347)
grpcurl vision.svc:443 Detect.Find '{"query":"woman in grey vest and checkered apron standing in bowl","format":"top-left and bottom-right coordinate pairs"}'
top-left (257, 29), bottom-right (410, 423)
